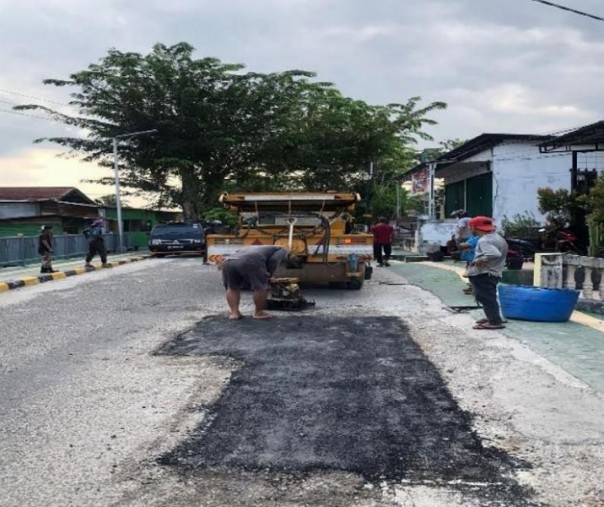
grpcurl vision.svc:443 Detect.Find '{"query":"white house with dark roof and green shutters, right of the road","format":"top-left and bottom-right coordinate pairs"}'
top-left (405, 122), bottom-right (604, 250)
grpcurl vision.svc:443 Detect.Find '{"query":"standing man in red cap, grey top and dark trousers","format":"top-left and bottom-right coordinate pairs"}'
top-left (468, 216), bottom-right (508, 329)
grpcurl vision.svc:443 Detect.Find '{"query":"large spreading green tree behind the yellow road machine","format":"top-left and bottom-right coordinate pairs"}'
top-left (19, 43), bottom-right (445, 218)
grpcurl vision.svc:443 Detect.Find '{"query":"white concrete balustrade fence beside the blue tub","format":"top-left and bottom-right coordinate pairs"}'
top-left (534, 253), bottom-right (604, 301)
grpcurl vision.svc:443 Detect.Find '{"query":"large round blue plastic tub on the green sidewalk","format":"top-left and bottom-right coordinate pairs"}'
top-left (498, 283), bottom-right (580, 322)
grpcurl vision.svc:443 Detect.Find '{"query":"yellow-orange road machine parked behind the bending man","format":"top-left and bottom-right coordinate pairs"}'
top-left (206, 192), bottom-right (373, 290)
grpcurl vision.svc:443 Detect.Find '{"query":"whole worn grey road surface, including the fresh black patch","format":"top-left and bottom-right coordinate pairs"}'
top-left (0, 258), bottom-right (604, 507)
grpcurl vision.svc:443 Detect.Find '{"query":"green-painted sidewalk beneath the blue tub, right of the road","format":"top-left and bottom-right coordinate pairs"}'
top-left (380, 261), bottom-right (604, 393)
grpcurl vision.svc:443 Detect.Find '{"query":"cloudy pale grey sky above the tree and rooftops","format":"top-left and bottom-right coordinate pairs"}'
top-left (0, 0), bottom-right (604, 205)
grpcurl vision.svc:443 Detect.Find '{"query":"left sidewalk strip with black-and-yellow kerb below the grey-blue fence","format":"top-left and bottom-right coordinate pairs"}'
top-left (0, 252), bottom-right (149, 292)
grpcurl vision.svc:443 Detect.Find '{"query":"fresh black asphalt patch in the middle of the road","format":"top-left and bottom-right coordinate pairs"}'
top-left (158, 315), bottom-right (528, 505)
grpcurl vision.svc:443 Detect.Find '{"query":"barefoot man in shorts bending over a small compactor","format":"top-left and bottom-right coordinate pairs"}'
top-left (222, 245), bottom-right (287, 320)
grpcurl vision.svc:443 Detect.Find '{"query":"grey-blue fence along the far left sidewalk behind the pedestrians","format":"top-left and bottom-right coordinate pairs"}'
top-left (0, 233), bottom-right (143, 267)
